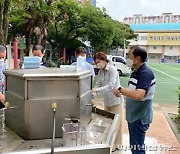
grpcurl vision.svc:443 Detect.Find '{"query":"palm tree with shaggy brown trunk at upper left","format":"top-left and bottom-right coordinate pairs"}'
top-left (9, 0), bottom-right (53, 55)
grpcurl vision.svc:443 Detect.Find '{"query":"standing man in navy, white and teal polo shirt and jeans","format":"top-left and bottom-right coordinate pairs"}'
top-left (114, 47), bottom-right (155, 154)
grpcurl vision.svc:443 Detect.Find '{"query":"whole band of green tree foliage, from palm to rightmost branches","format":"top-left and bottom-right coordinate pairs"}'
top-left (8, 0), bottom-right (134, 55)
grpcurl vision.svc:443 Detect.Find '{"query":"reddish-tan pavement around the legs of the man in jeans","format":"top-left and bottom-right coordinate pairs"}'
top-left (94, 98), bottom-right (180, 154)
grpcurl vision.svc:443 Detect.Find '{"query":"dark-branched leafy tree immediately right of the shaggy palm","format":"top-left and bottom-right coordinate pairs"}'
top-left (48, 0), bottom-right (85, 48)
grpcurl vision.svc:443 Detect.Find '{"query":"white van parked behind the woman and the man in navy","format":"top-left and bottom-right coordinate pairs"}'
top-left (107, 55), bottom-right (131, 75)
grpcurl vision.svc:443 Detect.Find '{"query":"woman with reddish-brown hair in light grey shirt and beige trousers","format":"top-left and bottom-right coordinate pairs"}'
top-left (92, 52), bottom-right (124, 152)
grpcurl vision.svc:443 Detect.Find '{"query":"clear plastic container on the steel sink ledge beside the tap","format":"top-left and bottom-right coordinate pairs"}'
top-left (62, 123), bottom-right (86, 147)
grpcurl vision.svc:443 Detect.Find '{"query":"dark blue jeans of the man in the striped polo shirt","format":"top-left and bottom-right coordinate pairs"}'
top-left (128, 121), bottom-right (149, 154)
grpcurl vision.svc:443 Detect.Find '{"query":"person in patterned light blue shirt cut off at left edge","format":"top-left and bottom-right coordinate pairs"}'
top-left (0, 45), bottom-right (6, 108)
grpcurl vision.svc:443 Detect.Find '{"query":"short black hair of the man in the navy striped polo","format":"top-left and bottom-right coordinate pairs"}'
top-left (133, 47), bottom-right (147, 63)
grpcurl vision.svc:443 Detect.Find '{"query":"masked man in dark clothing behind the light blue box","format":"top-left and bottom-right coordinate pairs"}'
top-left (32, 45), bottom-right (50, 67)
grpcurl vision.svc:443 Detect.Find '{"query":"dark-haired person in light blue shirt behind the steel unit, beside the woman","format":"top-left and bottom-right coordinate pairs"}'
top-left (71, 47), bottom-right (95, 79)
